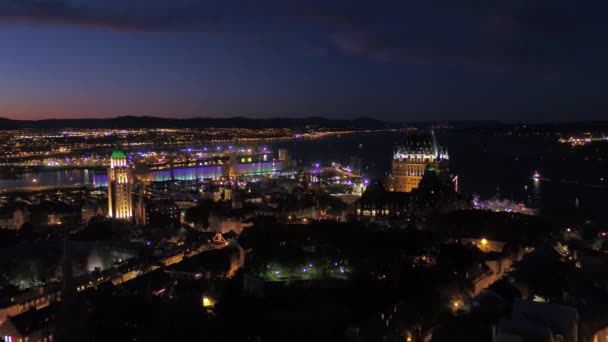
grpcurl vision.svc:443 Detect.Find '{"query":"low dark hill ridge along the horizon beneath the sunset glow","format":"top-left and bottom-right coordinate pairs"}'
top-left (0, 116), bottom-right (389, 129)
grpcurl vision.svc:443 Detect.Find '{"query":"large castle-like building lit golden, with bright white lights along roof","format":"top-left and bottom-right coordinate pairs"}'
top-left (386, 131), bottom-right (449, 192)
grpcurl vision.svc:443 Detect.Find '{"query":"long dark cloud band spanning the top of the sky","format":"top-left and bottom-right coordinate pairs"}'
top-left (0, 0), bottom-right (608, 75)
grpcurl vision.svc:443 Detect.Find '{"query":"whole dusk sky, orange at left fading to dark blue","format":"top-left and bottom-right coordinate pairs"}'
top-left (0, 0), bottom-right (608, 121)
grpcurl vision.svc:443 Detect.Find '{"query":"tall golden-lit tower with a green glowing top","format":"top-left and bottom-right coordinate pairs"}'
top-left (108, 148), bottom-right (133, 220)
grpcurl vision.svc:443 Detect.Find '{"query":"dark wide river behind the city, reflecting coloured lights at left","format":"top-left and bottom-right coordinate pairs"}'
top-left (0, 132), bottom-right (608, 224)
